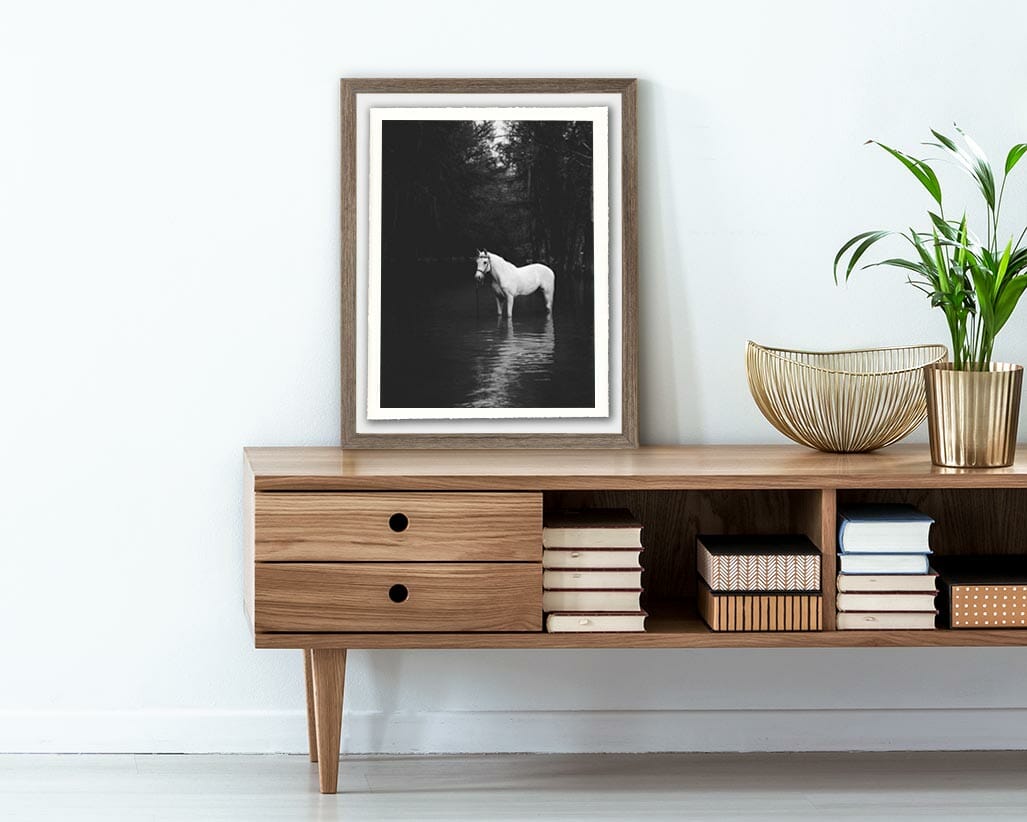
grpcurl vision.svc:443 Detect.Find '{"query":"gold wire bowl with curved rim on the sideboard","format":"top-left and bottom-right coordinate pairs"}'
top-left (746, 340), bottom-right (949, 453)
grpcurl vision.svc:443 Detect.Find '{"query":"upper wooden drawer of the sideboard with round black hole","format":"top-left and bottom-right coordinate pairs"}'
top-left (255, 491), bottom-right (542, 562)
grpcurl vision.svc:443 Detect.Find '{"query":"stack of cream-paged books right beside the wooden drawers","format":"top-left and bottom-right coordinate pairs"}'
top-left (542, 509), bottom-right (646, 632)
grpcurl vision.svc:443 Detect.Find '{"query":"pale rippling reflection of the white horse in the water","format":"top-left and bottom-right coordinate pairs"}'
top-left (465, 315), bottom-right (556, 408)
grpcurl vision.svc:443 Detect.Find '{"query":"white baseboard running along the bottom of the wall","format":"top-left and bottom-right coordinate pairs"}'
top-left (0, 708), bottom-right (1027, 754)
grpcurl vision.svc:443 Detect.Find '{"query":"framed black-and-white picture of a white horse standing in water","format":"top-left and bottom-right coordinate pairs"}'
top-left (342, 79), bottom-right (638, 448)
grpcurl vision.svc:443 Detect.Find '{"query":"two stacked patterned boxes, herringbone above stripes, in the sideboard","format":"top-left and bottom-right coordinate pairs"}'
top-left (695, 534), bottom-right (824, 631)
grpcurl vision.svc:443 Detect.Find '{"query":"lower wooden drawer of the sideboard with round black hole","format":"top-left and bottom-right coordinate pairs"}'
top-left (255, 562), bottom-right (542, 632)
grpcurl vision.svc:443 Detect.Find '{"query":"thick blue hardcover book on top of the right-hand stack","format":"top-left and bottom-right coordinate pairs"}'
top-left (838, 503), bottom-right (935, 554)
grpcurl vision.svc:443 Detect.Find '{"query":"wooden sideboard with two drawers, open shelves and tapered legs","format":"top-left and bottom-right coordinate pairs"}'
top-left (244, 445), bottom-right (1027, 793)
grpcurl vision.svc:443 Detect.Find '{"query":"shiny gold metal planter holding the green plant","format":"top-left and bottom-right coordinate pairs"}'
top-left (923, 363), bottom-right (1024, 469)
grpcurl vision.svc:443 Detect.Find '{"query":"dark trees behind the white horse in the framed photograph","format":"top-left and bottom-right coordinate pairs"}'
top-left (382, 120), bottom-right (594, 304)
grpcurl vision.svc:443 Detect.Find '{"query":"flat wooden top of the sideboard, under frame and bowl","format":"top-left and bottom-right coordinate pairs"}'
top-left (245, 444), bottom-right (1027, 491)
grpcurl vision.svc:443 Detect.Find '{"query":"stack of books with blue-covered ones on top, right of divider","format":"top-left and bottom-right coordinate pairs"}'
top-left (837, 503), bottom-right (938, 631)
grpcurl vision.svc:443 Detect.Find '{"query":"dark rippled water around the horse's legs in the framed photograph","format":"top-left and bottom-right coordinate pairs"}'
top-left (381, 269), bottom-right (595, 408)
